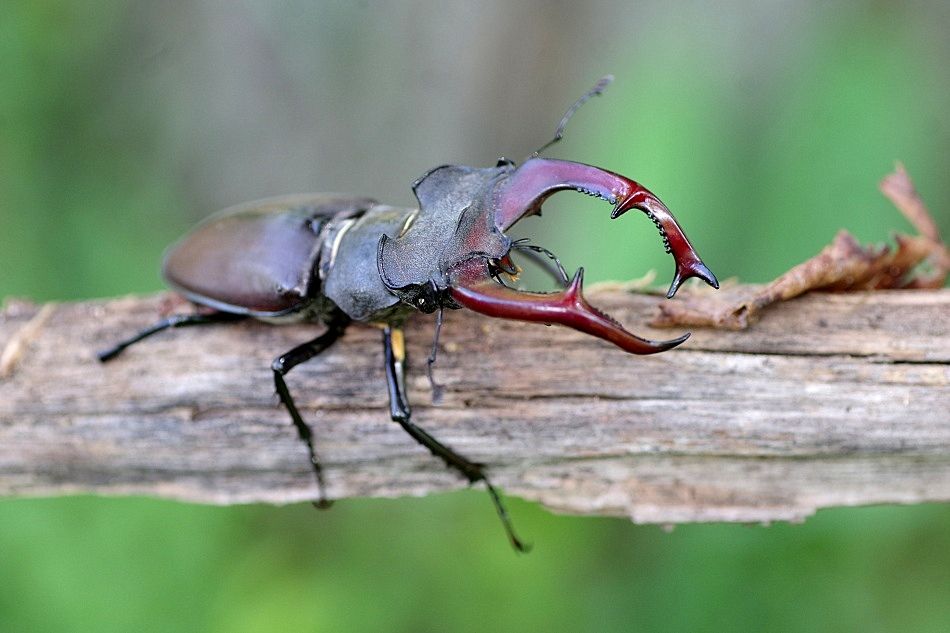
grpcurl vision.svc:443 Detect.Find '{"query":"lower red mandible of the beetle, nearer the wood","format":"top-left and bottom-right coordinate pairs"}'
top-left (449, 259), bottom-right (689, 354)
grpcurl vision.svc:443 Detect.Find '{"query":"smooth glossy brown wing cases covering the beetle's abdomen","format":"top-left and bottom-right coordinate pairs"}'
top-left (162, 194), bottom-right (375, 317)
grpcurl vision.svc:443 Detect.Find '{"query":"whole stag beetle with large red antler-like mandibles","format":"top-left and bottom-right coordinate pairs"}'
top-left (98, 77), bottom-right (719, 550)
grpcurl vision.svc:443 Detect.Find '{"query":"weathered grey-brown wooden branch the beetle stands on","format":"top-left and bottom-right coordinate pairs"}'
top-left (0, 290), bottom-right (950, 522)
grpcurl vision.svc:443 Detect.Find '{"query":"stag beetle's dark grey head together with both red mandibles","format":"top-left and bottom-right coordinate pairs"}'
top-left (377, 157), bottom-right (719, 354)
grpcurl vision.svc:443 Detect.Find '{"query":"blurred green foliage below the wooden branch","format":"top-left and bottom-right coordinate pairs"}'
top-left (0, 491), bottom-right (950, 633)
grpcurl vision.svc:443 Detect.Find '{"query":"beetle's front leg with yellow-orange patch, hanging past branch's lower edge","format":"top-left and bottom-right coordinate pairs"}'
top-left (383, 326), bottom-right (529, 552)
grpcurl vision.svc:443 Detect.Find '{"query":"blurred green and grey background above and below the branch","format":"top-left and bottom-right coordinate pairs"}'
top-left (0, 0), bottom-right (950, 633)
